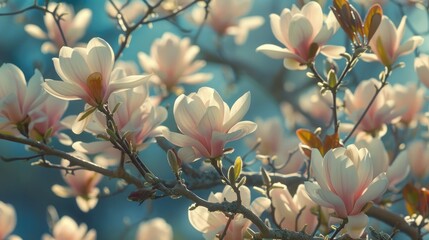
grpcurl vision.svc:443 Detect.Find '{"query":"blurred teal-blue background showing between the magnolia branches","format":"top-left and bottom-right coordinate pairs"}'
top-left (0, 0), bottom-right (429, 239)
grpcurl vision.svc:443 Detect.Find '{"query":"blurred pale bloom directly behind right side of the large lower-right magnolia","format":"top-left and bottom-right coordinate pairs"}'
top-left (355, 138), bottom-right (410, 190)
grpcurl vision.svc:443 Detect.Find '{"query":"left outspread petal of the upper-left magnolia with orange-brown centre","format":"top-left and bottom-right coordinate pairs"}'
top-left (42, 79), bottom-right (87, 100)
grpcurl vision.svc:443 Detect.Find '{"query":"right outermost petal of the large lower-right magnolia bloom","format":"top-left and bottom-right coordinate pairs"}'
top-left (350, 173), bottom-right (389, 214)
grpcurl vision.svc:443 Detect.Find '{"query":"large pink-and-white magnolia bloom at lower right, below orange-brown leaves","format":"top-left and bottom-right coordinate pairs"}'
top-left (305, 145), bottom-right (388, 238)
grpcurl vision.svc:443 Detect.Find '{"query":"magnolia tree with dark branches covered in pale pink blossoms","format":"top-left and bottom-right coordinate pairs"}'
top-left (0, 0), bottom-right (429, 240)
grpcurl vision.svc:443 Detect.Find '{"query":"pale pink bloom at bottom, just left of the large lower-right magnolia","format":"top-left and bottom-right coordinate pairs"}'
top-left (270, 183), bottom-right (317, 234)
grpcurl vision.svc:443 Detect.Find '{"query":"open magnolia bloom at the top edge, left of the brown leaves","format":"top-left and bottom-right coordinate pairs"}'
top-left (256, 2), bottom-right (345, 70)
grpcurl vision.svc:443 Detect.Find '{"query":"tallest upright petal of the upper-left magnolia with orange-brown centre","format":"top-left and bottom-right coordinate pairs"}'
top-left (87, 38), bottom-right (115, 78)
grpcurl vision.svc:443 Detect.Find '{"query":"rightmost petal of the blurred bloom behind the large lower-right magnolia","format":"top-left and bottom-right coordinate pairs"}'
top-left (386, 151), bottom-right (410, 189)
